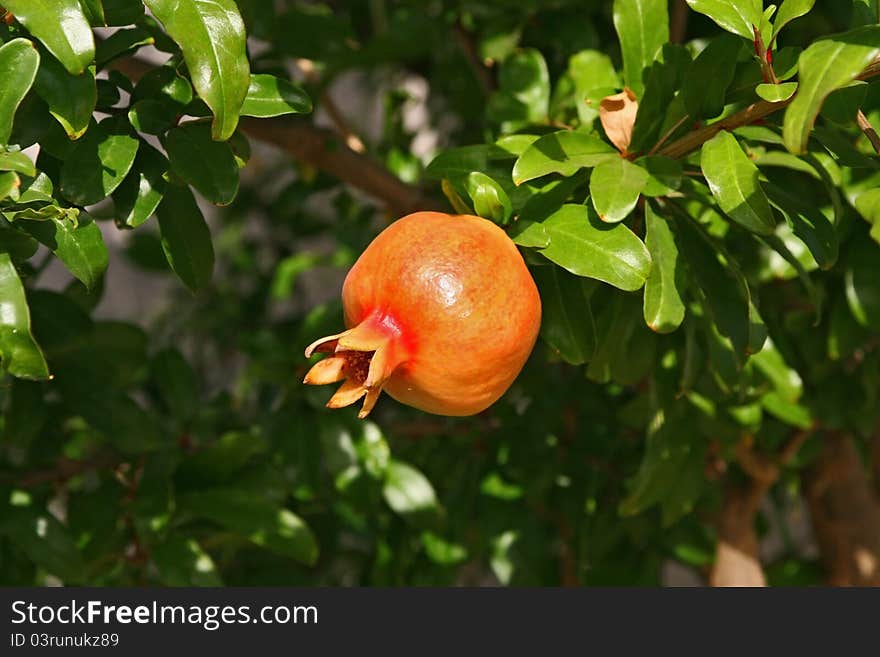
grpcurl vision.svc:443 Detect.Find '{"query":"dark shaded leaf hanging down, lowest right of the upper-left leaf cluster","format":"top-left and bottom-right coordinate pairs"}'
top-left (156, 185), bottom-right (214, 292)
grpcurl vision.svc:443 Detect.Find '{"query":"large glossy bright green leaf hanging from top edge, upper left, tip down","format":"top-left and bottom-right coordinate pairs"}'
top-left (144, 0), bottom-right (250, 141)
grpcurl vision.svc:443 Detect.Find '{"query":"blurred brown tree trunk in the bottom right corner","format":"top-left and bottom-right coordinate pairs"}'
top-left (806, 434), bottom-right (880, 586)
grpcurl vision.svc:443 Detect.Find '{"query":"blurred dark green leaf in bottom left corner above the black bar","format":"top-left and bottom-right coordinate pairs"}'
top-left (0, 502), bottom-right (86, 584)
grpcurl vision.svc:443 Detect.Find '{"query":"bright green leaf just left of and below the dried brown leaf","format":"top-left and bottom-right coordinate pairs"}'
top-left (512, 130), bottom-right (620, 185)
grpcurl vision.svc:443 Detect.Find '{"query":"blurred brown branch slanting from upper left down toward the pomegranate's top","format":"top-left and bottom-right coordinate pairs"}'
top-left (106, 57), bottom-right (440, 215)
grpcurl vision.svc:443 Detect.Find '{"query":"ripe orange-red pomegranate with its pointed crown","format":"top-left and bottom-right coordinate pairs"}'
top-left (305, 212), bottom-right (541, 418)
